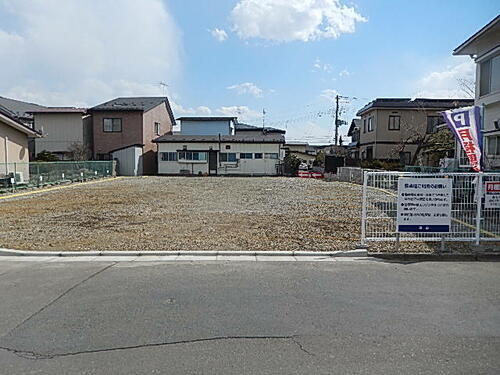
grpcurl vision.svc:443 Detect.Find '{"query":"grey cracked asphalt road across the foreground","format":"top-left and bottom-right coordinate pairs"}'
top-left (0, 260), bottom-right (500, 375)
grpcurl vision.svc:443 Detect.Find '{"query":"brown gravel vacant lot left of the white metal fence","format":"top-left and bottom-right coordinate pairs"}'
top-left (0, 177), bottom-right (361, 251)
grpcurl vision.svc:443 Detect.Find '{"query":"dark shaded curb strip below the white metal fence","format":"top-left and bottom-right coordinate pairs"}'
top-left (368, 252), bottom-right (500, 262)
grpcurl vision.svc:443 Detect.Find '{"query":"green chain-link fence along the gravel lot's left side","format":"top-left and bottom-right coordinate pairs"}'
top-left (0, 161), bottom-right (115, 193)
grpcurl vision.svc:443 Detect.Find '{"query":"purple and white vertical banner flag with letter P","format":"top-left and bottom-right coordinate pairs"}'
top-left (441, 106), bottom-right (483, 172)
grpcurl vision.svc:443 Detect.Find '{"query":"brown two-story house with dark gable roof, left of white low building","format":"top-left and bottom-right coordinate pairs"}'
top-left (89, 97), bottom-right (175, 174)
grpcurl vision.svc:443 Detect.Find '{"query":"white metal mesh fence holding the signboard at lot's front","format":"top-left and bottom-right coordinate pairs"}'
top-left (361, 172), bottom-right (500, 244)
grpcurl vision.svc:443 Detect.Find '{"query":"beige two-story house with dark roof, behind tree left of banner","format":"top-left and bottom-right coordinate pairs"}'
top-left (351, 98), bottom-right (474, 165)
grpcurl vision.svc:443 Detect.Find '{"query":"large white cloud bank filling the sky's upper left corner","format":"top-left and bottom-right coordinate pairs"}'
top-left (0, 0), bottom-right (181, 106)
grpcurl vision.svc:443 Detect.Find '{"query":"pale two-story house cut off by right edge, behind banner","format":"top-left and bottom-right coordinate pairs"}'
top-left (453, 16), bottom-right (500, 169)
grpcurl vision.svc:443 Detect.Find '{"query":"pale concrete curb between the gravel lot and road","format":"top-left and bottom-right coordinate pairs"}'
top-left (0, 248), bottom-right (368, 259)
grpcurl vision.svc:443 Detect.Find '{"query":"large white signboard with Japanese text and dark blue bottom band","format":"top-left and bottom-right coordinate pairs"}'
top-left (396, 177), bottom-right (453, 233)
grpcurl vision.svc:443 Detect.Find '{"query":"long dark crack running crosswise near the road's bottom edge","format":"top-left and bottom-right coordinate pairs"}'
top-left (0, 335), bottom-right (314, 360)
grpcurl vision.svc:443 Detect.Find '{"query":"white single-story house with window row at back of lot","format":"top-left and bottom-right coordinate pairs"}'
top-left (154, 134), bottom-right (285, 176)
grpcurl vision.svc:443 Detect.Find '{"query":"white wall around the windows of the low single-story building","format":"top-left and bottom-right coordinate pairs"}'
top-left (158, 142), bottom-right (283, 176)
